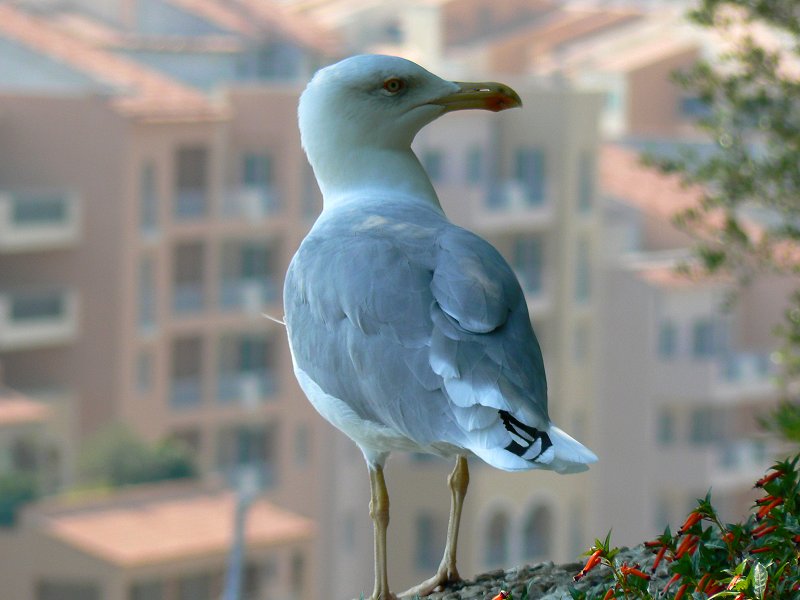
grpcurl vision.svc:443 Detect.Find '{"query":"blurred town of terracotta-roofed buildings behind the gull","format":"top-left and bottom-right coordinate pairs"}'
top-left (0, 0), bottom-right (796, 600)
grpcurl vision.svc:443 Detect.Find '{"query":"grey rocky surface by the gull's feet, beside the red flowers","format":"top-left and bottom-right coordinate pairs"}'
top-left (428, 546), bottom-right (668, 600)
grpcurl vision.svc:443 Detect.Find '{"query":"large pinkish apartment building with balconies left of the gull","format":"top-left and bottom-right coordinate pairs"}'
top-left (0, 4), bottom-right (328, 597)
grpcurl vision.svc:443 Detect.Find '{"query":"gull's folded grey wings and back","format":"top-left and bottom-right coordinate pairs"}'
top-left (284, 209), bottom-right (549, 458)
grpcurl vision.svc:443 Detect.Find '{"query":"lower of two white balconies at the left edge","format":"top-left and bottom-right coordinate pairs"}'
top-left (0, 289), bottom-right (78, 350)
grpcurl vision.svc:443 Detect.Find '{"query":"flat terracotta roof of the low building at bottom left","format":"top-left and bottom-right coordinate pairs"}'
top-left (40, 490), bottom-right (314, 567)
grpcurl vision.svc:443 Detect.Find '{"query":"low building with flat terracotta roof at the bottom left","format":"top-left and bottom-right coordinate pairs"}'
top-left (0, 484), bottom-right (316, 600)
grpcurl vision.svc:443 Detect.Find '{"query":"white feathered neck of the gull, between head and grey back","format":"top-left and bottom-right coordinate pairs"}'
top-left (309, 146), bottom-right (442, 212)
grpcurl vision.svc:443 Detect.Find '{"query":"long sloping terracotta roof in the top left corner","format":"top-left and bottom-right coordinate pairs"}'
top-left (0, 3), bottom-right (222, 120)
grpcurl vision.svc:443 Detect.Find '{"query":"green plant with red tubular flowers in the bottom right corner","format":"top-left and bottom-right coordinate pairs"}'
top-left (572, 455), bottom-right (800, 600)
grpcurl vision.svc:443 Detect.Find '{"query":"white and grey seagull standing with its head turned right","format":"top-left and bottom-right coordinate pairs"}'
top-left (283, 55), bottom-right (597, 600)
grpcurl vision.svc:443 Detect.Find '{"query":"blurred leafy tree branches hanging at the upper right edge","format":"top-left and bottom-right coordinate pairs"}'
top-left (645, 0), bottom-right (800, 441)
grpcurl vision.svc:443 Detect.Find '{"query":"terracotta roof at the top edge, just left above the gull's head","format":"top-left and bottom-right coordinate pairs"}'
top-left (169, 0), bottom-right (337, 54)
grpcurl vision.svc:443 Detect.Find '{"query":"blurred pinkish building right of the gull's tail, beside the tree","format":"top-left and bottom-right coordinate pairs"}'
top-left (596, 145), bottom-right (780, 544)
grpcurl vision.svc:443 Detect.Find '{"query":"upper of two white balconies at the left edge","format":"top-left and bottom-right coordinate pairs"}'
top-left (0, 190), bottom-right (81, 252)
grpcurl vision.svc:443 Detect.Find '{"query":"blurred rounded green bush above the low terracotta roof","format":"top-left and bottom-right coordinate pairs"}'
top-left (79, 424), bottom-right (197, 487)
